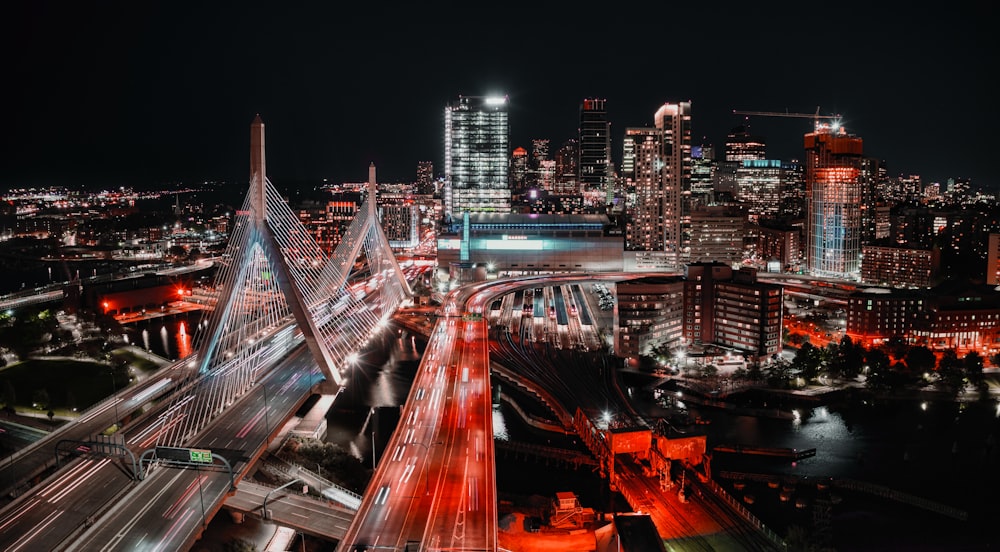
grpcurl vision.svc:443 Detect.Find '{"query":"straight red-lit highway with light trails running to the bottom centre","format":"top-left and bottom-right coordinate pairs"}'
top-left (338, 303), bottom-right (497, 551)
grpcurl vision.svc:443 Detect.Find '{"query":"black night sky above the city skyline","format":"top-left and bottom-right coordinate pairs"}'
top-left (0, 0), bottom-right (1000, 189)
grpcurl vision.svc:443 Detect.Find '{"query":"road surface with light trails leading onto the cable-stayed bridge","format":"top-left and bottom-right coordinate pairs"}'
top-left (0, 334), bottom-right (318, 552)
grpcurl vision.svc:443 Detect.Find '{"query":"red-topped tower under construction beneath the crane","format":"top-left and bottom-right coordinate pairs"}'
top-left (805, 122), bottom-right (862, 280)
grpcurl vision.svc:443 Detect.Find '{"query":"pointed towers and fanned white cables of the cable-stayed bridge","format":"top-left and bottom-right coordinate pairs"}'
top-left (156, 116), bottom-right (412, 447)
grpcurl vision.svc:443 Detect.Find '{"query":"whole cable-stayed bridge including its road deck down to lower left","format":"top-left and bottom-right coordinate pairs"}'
top-left (0, 117), bottom-right (450, 551)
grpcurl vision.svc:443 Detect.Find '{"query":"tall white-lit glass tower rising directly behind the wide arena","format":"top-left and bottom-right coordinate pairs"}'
top-left (444, 96), bottom-right (511, 221)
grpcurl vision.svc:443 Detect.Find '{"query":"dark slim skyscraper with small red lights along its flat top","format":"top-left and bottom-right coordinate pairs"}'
top-left (578, 98), bottom-right (614, 203)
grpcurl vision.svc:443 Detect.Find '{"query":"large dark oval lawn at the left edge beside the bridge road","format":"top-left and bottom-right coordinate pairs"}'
top-left (0, 359), bottom-right (128, 411)
